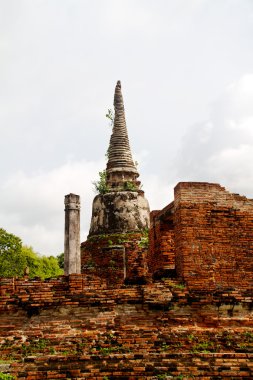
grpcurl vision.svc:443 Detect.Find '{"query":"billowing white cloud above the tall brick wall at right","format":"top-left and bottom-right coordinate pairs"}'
top-left (176, 74), bottom-right (253, 197)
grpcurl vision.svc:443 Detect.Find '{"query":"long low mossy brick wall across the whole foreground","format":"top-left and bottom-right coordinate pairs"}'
top-left (0, 274), bottom-right (253, 380)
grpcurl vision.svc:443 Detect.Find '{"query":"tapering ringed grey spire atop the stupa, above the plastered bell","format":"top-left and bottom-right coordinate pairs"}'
top-left (106, 81), bottom-right (140, 188)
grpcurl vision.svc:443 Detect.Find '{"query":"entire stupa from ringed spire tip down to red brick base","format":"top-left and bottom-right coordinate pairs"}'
top-left (81, 81), bottom-right (150, 286)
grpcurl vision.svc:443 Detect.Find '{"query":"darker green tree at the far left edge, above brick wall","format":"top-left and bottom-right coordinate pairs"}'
top-left (0, 228), bottom-right (26, 277)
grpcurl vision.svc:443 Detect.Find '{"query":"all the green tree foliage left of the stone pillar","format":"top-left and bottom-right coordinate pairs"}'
top-left (0, 228), bottom-right (63, 279)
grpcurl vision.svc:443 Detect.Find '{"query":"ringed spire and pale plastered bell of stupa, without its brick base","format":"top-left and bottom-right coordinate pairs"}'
top-left (89, 81), bottom-right (149, 236)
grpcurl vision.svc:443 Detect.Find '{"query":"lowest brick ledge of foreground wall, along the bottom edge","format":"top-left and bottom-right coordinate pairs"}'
top-left (10, 352), bottom-right (253, 380)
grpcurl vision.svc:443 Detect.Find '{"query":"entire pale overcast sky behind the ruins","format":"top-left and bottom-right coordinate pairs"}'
top-left (0, 0), bottom-right (253, 255)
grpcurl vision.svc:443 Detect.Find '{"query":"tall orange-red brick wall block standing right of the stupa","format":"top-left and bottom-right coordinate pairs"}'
top-left (174, 182), bottom-right (253, 291)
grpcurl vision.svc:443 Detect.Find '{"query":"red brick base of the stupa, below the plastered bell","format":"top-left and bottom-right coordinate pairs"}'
top-left (81, 233), bottom-right (147, 286)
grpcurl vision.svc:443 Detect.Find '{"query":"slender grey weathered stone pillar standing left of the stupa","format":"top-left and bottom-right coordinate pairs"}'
top-left (64, 194), bottom-right (81, 275)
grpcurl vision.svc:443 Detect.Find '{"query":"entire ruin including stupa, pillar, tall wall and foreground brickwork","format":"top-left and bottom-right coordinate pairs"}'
top-left (0, 82), bottom-right (253, 380)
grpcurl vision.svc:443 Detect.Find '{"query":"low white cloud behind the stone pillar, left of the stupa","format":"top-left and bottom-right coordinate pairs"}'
top-left (0, 161), bottom-right (104, 254)
